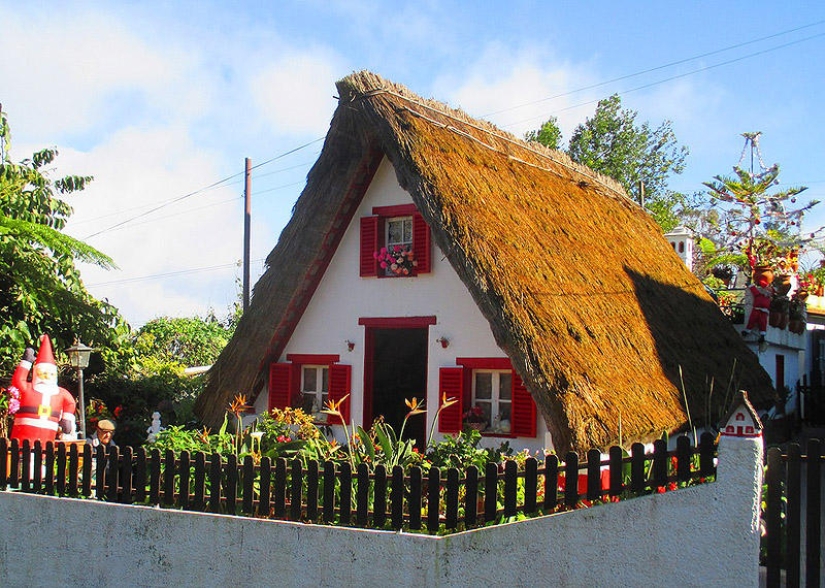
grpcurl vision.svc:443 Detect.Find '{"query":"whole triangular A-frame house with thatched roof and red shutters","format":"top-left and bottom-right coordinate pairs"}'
top-left (196, 72), bottom-right (773, 451)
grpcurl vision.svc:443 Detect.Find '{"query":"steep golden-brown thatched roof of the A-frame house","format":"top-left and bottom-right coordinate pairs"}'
top-left (196, 72), bottom-right (773, 449)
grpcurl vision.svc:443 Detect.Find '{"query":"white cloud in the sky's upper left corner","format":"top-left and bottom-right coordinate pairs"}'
top-left (0, 8), bottom-right (200, 140)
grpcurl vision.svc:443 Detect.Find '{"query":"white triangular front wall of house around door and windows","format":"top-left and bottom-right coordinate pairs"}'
top-left (248, 159), bottom-right (552, 451)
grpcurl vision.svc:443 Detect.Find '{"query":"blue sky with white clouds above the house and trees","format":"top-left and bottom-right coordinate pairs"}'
top-left (0, 0), bottom-right (825, 326)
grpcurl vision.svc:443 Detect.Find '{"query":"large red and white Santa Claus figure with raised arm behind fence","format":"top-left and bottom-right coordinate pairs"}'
top-left (11, 335), bottom-right (77, 444)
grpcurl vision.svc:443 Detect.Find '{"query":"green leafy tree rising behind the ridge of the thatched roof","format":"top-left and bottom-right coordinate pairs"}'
top-left (525, 94), bottom-right (688, 232)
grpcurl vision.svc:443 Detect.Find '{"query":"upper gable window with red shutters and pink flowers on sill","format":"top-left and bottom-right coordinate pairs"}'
top-left (360, 204), bottom-right (431, 278)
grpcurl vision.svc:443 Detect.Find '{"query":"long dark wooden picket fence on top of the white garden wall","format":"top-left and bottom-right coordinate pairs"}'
top-left (0, 434), bottom-right (716, 534)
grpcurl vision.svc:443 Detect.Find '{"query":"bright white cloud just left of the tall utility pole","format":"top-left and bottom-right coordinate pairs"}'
top-left (59, 127), bottom-right (243, 323)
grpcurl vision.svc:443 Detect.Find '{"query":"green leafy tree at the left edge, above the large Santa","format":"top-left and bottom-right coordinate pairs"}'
top-left (0, 109), bottom-right (129, 373)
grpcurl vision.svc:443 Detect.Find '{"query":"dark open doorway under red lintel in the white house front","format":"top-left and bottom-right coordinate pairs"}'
top-left (364, 327), bottom-right (428, 451)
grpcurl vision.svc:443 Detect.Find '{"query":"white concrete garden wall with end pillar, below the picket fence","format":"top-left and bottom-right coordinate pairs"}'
top-left (0, 438), bottom-right (762, 588)
